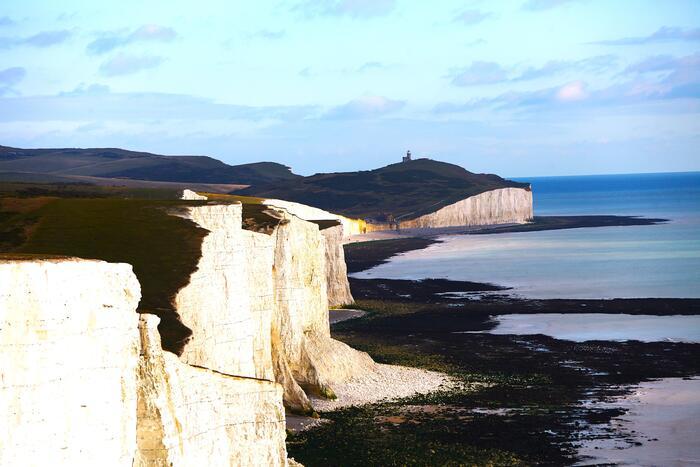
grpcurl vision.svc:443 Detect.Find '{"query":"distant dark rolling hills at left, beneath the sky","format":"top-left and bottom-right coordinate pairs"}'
top-left (0, 146), bottom-right (299, 185)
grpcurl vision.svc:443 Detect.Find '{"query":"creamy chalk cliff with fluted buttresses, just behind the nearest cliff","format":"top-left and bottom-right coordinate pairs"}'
top-left (175, 204), bottom-right (374, 412)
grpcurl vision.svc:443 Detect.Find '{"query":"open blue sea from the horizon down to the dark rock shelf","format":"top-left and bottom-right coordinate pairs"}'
top-left (355, 172), bottom-right (700, 298)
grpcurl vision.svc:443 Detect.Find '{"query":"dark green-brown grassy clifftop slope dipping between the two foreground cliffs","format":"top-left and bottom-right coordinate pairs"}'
top-left (0, 186), bottom-right (216, 353)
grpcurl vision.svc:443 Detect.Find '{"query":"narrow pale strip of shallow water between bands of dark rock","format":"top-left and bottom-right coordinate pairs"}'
top-left (467, 313), bottom-right (700, 343)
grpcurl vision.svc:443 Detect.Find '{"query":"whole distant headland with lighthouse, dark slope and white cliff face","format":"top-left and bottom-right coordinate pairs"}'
top-left (236, 159), bottom-right (532, 235)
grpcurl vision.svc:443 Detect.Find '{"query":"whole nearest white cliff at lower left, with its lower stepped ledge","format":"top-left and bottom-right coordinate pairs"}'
top-left (0, 259), bottom-right (287, 467)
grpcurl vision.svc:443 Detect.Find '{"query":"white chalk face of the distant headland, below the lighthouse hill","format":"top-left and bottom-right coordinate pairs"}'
top-left (399, 188), bottom-right (533, 229)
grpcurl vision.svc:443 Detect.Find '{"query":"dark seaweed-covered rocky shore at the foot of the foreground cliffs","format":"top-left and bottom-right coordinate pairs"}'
top-left (288, 229), bottom-right (700, 466)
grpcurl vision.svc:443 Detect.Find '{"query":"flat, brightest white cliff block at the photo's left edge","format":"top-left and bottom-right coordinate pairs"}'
top-left (0, 259), bottom-right (141, 466)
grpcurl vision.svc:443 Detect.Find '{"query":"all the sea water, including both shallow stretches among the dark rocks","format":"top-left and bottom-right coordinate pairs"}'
top-left (354, 172), bottom-right (700, 466)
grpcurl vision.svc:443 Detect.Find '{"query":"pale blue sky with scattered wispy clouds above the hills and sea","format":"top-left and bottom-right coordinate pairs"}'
top-left (0, 0), bottom-right (700, 177)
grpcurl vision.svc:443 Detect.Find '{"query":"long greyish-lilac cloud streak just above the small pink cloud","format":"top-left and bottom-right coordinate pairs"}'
top-left (448, 55), bottom-right (617, 86)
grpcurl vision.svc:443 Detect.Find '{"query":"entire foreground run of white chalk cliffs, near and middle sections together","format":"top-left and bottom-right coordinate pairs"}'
top-left (0, 188), bottom-right (470, 467)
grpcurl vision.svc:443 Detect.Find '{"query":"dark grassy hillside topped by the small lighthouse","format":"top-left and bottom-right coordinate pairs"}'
top-left (237, 159), bottom-right (529, 222)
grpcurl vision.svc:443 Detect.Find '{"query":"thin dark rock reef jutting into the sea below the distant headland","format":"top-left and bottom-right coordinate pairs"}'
top-left (470, 216), bottom-right (668, 235)
